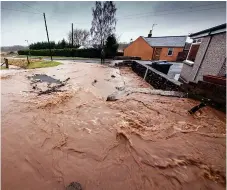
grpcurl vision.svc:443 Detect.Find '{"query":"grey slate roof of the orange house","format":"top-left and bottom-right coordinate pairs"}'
top-left (142, 36), bottom-right (187, 47)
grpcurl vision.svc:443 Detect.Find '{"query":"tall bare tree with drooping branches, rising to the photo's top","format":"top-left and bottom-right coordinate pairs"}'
top-left (90, 1), bottom-right (117, 47)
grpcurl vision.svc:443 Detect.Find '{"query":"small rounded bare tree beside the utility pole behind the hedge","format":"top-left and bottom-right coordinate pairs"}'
top-left (68, 28), bottom-right (90, 46)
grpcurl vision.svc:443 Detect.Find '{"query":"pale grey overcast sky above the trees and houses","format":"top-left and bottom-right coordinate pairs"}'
top-left (1, 1), bottom-right (226, 46)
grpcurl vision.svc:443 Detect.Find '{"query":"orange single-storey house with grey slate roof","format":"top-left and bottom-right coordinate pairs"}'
top-left (124, 33), bottom-right (187, 61)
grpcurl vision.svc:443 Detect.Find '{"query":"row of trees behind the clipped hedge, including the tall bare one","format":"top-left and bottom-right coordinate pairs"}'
top-left (29, 1), bottom-right (118, 54)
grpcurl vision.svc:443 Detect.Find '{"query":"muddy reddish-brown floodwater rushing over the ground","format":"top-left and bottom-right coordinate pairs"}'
top-left (1, 61), bottom-right (226, 190)
